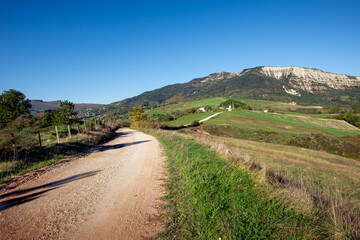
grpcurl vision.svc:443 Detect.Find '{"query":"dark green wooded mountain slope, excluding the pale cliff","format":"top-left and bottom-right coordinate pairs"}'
top-left (112, 68), bottom-right (360, 107)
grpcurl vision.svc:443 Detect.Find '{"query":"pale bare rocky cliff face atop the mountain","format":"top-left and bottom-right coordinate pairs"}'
top-left (259, 67), bottom-right (360, 93)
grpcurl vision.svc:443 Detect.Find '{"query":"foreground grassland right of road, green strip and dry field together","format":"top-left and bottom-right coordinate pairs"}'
top-left (152, 131), bottom-right (360, 239)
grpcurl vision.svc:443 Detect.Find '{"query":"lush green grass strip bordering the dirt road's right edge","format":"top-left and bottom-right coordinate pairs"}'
top-left (151, 131), bottom-right (320, 239)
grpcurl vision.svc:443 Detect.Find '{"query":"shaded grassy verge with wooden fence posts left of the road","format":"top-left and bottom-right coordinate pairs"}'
top-left (0, 116), bottom-right (117, 183)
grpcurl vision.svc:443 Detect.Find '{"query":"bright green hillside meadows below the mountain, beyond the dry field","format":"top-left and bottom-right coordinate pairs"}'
top-left (147, 97), bottom-right (360, 137)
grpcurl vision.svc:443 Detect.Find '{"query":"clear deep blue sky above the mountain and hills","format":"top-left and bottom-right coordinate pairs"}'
top-left (0, 0), bottom-right (360, 103)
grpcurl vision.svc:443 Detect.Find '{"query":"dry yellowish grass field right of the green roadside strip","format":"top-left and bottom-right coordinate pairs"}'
top-left (191, 133), bottom-right (360, 239)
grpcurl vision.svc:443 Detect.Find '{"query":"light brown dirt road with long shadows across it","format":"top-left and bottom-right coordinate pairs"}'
top-left (0, 129), bottom-right (165, 239)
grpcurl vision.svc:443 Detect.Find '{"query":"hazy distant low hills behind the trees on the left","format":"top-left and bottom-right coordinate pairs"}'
top-left (30, 100), bottom-right (104, 116)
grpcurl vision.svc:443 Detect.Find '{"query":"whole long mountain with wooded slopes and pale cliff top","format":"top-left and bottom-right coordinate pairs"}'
top-left (112, 67), bottom-right (360, 107)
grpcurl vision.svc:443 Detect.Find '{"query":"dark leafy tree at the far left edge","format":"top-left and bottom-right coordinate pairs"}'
top-left (0, 89), bottom-right (31, 127)
